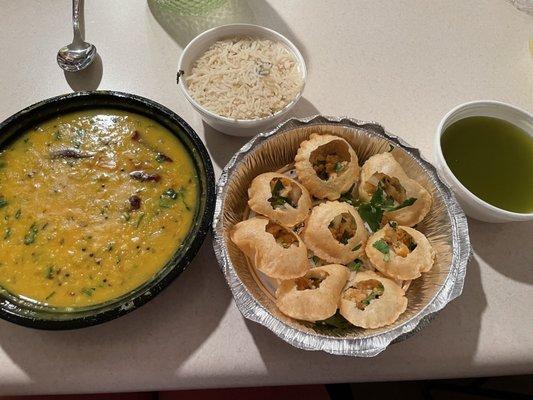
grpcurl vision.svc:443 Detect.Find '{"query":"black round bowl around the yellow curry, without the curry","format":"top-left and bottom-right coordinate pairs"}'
top-left (0, 91), bottom-right (215, 329)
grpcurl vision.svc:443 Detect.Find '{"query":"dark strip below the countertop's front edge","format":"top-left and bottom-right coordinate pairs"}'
top-left (0, 375), bottom-right (533, 400)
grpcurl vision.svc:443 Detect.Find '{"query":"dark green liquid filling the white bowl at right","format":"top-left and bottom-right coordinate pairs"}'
top-left (441, 117), bottom-right (533, 213)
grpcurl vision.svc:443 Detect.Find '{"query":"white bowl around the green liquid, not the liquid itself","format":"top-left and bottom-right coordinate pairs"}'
top-left (435, 101), bottom-right (533, 222)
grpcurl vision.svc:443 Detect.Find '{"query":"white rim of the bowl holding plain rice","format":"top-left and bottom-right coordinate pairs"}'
top-left (176, 23), bottom-right (307, 127)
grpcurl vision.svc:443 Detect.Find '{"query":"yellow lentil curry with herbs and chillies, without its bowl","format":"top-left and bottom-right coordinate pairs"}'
top-left (0, 109), bottom-right (198, 307)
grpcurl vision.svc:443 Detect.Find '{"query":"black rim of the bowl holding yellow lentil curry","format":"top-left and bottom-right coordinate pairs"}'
top-left (0, 90), bottom-right (215, 330)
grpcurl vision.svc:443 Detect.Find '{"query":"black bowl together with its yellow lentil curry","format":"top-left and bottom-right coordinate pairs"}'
top-left (0, 91), bottom-right (214, 329)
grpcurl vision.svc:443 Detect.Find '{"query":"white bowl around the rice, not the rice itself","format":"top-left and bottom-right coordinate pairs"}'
top-left (178, 24), bottom-right (307, 136)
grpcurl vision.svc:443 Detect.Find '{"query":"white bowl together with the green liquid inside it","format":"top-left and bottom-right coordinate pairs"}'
top-left (435, 101), bottom-right (533, 222)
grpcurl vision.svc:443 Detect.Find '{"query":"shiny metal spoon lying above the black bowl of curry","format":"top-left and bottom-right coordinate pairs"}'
top-left (57, 0), bottom-right (96, 72)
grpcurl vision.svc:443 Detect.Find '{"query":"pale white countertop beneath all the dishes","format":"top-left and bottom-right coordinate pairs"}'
top-left (0, 0), bottom-right (533, 394)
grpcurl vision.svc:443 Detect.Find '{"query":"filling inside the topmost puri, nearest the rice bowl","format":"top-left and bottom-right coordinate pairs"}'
top-left (309, 140), bottom-right (351, 181)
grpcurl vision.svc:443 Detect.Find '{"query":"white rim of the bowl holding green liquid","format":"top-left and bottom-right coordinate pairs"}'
top-left (434, 100), bottom-right (533, 221)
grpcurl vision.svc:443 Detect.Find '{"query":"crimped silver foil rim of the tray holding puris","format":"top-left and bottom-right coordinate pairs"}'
top-left (213, 115), bottom-right (472, 357)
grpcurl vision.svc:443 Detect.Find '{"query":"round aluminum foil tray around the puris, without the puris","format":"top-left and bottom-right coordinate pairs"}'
top-left (213, 116), bottom-right (471, 357)
